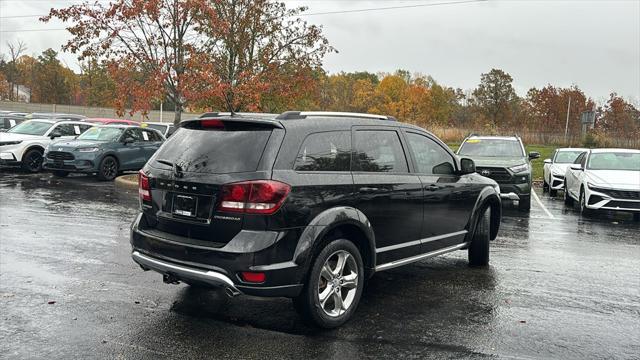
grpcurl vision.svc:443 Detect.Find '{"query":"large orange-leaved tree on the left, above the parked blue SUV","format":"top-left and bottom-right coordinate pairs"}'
top-left (41, 0), bottom-right (219, 122)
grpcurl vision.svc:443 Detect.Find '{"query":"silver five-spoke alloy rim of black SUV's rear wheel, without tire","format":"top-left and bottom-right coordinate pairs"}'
top-left (318, 250), bottom-right (358, 317)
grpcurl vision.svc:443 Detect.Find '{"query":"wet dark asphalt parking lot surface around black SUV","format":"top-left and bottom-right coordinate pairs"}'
top-left (0, 170), bottom-right (640, 359)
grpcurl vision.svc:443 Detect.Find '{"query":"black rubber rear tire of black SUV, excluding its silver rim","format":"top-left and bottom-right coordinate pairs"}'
top-left (294, 239), bottom-right (365, 329)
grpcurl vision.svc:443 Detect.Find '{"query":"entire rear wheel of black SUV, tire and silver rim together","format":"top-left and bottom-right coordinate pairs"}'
top-left (293, 239), bottom-right (364, 329)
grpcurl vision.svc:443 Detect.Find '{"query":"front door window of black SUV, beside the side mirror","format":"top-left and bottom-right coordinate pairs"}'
top-left (407, 133), bottom-right (455, 174)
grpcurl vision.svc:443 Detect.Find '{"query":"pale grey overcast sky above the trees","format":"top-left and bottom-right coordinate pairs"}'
top-left (0, 0), bottom-right (640, 105)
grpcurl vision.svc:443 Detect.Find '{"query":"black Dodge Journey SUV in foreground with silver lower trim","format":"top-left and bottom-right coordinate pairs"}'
top-left (131, 112), bottom-right (501, 328)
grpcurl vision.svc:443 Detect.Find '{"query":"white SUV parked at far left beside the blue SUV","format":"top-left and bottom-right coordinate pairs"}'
top-left (0, 119), bottom-right (93, 172)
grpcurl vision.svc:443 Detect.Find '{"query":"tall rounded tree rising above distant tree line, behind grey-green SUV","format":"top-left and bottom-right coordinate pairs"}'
top-left (472, 69), bottom-right (518, 127)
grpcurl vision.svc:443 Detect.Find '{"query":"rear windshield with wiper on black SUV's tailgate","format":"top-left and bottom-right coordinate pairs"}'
top-left (153, 126), bottom-right (272, 174)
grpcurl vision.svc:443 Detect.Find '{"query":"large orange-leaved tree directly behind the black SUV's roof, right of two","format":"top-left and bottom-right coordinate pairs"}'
top-left (188, 0), bottom-right (333, 111)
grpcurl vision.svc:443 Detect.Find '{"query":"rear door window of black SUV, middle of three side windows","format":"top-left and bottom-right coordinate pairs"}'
top-left (354, 130), bottom-right (409, 173)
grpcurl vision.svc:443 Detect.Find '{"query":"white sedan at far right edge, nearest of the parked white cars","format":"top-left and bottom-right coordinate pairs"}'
top-left (564, 149), bottom-right (640, 220)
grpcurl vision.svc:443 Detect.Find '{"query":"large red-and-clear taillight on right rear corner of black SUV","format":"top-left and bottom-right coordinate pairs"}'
top-left (218, 180), bottom-right (291, 215)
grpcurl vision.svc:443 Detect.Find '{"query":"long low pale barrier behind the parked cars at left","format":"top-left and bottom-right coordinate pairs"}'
top-left (0, 101), bottom-right (200, 122)
